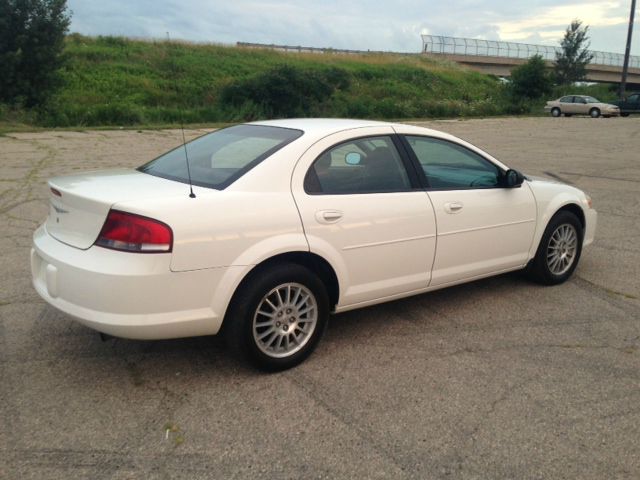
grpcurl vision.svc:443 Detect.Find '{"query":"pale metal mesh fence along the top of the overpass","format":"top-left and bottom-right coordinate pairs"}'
top-left (422, 35), bottom-right (640, 68)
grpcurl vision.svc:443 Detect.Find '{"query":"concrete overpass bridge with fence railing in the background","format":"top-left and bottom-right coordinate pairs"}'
top-left (422, 35), bottom-right (640, 89)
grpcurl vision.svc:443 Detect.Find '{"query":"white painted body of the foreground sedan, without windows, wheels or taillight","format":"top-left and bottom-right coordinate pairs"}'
top-left (31, 119), bottom-right (597, 339)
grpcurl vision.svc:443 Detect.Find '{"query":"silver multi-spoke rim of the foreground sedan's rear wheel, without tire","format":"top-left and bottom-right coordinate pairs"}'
top-left (253, 283), bottom-right (318, 358)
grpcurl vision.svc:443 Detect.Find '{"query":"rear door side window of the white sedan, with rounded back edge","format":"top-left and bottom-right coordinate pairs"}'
top-left (304, 137), bottom-right (411, 194)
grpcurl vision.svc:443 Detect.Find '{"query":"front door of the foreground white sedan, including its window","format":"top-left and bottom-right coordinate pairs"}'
top-left (405, 136), bottom-right (536, 286)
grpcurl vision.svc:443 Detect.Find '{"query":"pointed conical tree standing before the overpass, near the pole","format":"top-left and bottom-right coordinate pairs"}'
top-left (555, 20), bottom-right (593, 85)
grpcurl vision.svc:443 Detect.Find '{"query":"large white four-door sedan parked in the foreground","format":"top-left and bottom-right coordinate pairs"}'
top-left (31, 119), bottom-right (597, 370)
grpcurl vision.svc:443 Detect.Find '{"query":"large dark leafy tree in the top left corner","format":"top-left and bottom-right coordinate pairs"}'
top-left (0, 0), bottom-right (70, 107)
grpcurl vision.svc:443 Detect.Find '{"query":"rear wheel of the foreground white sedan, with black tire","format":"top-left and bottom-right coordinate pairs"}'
top-left (223, 263), bottom-right (329, 372)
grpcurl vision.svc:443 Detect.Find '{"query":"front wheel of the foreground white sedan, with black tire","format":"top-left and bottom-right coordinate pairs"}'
top-left (526, 210), bottom-right (584, 285)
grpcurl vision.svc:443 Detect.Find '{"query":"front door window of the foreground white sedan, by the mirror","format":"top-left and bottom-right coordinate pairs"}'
top-left (406, 136), bottom-right (501, 190)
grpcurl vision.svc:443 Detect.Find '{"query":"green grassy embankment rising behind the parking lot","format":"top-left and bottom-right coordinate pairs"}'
top-left (0, 34), bottom-right (620, 130)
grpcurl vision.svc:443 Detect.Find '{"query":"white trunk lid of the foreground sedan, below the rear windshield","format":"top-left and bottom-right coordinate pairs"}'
top-left (45, 169), bottom-right (189, 250)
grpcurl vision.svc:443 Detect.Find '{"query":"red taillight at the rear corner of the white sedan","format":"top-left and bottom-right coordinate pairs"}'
top-left (96, 210), bottom-right (173, 253)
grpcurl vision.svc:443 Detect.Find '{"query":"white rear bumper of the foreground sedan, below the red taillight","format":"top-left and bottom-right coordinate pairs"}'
top-left (31, 227), bottom-right (227, 340)
